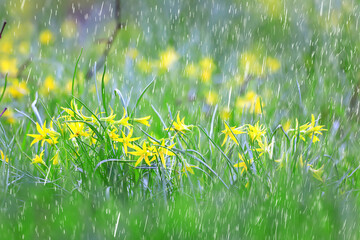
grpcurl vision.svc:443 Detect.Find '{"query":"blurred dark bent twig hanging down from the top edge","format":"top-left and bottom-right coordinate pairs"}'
top-left (86, 0), bottom-right (124, 80)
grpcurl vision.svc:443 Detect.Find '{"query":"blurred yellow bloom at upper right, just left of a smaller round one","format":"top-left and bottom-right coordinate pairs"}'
top-left (240, 52), bottom-right (264, 77)
